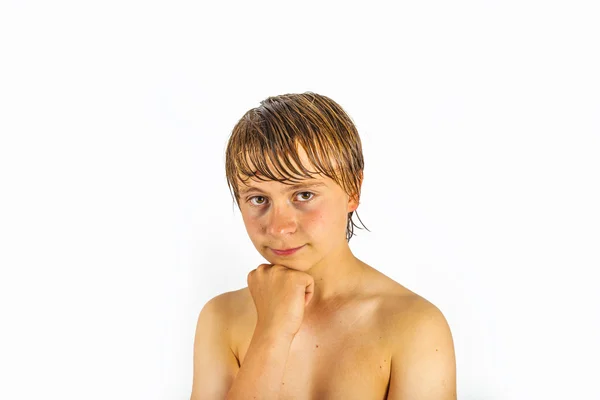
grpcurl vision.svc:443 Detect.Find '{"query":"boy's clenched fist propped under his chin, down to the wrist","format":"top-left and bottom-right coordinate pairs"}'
top-left (248, 264), bottom-right (315, 337)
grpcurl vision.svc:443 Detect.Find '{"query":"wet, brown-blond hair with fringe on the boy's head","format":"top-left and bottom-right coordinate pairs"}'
top-left (225, 92), bottom-right (368, 241)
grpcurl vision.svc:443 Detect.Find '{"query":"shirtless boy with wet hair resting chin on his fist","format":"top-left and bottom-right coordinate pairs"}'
top-left (191, 92), bottom-right (456, 400)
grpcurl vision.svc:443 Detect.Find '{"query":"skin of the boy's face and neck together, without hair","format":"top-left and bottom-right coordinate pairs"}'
top-left (239, 144), bottom-right (367, 310)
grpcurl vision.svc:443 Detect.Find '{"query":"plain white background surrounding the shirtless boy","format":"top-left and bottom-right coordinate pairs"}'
top-left (0, 0), bottom-right (600, 400)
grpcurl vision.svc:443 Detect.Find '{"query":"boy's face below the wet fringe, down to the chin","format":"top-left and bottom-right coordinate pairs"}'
top-left (239, 148), bottom-right (358, 271)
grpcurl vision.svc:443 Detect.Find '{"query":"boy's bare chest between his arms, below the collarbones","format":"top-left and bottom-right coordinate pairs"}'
top-left (234, 298), bottom-right (391, 400)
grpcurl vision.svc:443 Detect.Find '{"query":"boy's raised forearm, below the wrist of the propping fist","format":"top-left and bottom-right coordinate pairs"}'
top-left (226, 329), bottom-right (293, 400)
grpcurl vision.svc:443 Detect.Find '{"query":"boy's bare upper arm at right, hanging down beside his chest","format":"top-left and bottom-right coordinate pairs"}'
top-left (387, 301), bottom-right (456, 400)
